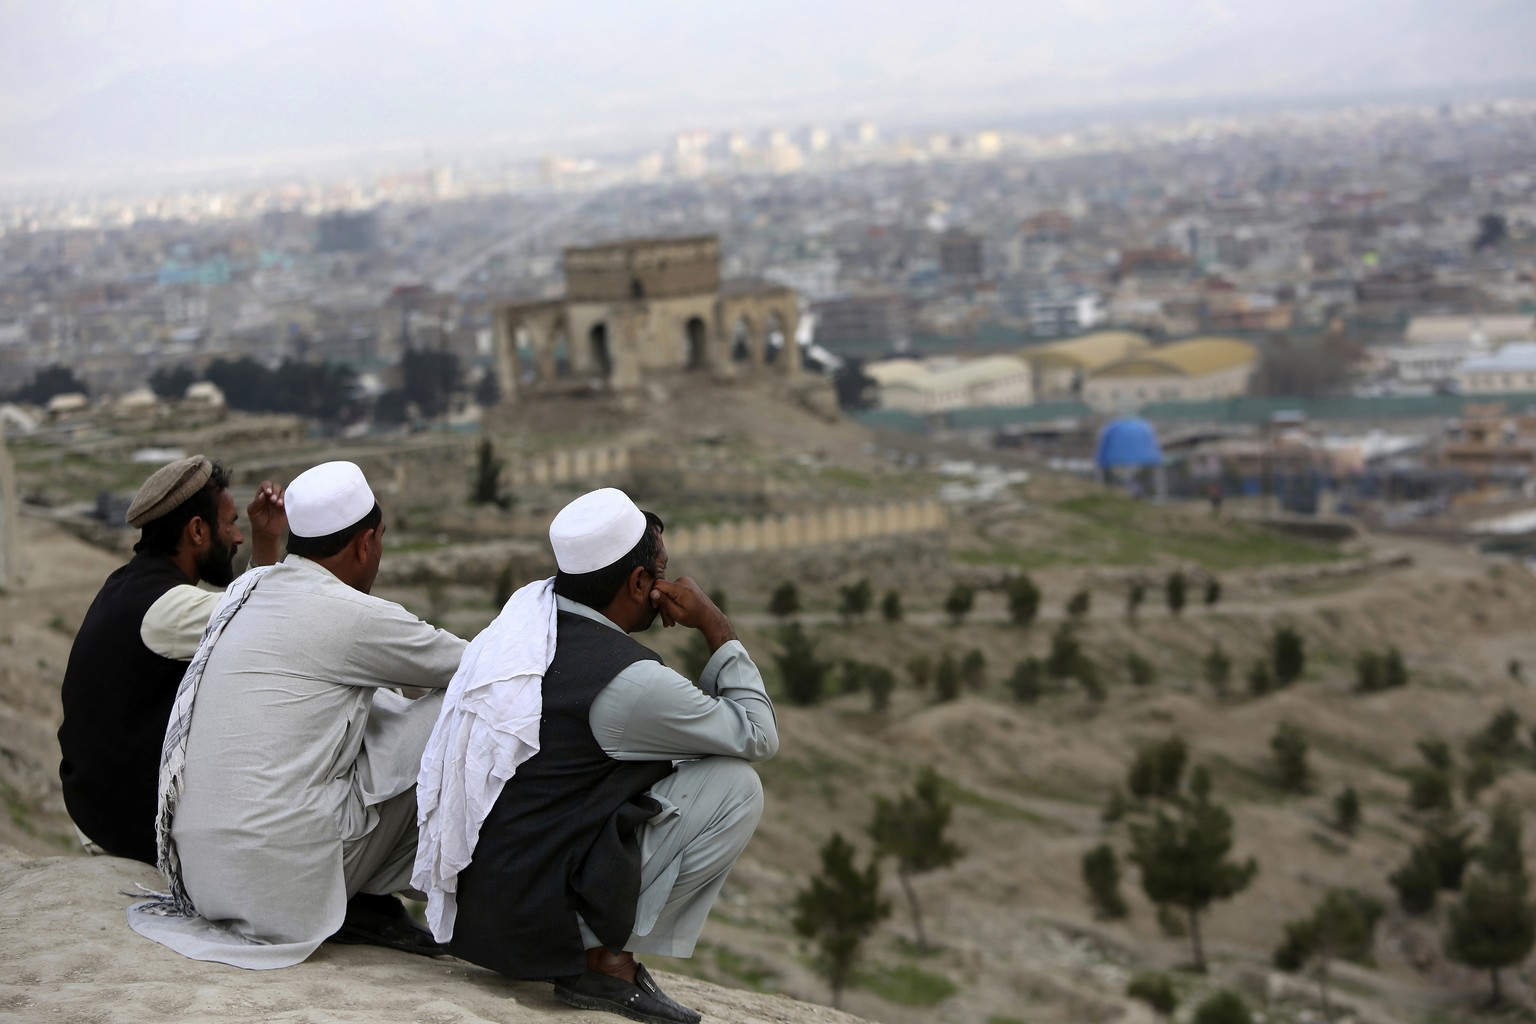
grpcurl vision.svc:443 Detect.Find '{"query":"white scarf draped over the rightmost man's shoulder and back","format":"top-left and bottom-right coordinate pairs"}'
top-left (410, 577), bottom-right (556, 943)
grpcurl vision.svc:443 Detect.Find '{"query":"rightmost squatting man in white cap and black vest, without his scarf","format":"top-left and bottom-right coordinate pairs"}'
top-left (442, 488), bottom-right (779, 1024)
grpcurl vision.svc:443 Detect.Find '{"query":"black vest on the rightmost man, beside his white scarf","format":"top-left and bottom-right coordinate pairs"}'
top-left (449, 611), bottom-right (673, 978)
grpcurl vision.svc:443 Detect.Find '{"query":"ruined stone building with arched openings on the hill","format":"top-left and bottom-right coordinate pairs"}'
top-left (495, 235), bottom-right (800, 401)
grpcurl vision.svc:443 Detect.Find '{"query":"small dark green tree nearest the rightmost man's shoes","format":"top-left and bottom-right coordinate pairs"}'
top-left (793, 832), bottom-right (891, 1007)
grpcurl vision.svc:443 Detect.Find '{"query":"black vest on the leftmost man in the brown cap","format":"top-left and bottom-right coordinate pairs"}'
top-left (58, 554), bottom-right (192, 864)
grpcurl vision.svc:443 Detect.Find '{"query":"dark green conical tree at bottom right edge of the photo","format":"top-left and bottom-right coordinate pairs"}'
top-left (1445, 798), bottom-right (1536, 1006)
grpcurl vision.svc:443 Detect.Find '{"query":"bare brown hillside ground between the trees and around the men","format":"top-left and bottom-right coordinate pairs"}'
top-left (0, 396), bottom-right (1536, 1024)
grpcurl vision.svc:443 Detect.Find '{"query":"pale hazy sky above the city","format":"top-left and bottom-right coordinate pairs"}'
top-left (0, 0), bottom-right (1536, 181)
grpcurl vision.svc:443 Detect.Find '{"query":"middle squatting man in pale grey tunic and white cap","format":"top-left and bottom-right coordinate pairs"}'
top-left (129, 462), bottom-right (464, 969)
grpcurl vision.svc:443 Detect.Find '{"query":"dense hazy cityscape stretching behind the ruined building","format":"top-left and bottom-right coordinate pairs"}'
top-left (0, 100), bottom-right (1536, 411)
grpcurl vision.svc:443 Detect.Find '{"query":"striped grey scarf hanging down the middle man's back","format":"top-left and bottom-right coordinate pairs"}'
top-left (134, 565), bottom-right (272, 918)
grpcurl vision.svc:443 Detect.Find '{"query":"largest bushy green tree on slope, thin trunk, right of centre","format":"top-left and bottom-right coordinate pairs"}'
top-left (1130, 768), bottom-right (1258, 972)
